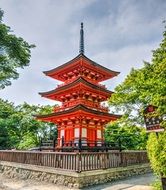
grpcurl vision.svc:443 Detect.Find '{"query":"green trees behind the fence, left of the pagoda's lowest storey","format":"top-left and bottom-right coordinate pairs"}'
top-left (0, 99), bottom-right (56, 149)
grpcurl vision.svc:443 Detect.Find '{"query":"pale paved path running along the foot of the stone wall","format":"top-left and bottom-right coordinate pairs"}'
top-left (0, 174), bottom-right (154, 190)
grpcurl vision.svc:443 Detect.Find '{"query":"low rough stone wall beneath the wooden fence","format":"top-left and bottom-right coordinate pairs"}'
top-left (0, 161), bottom-right (151, 189)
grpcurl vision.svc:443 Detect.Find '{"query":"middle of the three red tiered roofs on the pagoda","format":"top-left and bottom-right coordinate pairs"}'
top-left (39, 77), bottom-right (113, 99)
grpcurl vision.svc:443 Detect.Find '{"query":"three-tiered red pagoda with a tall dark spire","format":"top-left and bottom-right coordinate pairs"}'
top-left (36, 23), bottom-right (120, 150)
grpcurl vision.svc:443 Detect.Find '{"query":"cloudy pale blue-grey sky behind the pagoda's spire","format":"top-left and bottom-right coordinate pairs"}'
top-left (0, 0), bottom-right (166, 105)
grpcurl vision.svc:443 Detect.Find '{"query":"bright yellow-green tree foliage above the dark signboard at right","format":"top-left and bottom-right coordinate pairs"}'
top-left (109, 26), bottom-right (166, 123)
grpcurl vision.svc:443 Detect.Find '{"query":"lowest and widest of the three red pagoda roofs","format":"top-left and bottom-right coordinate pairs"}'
top-left (35, 104), bottom-right (121, 122)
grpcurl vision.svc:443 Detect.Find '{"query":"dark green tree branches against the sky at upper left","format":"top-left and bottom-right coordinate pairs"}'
top-left (0, 9), bottom-right (35, 89)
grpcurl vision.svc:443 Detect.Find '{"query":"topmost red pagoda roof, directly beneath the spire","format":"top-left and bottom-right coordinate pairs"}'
top-left (43, 53), bottom-right (120, 82)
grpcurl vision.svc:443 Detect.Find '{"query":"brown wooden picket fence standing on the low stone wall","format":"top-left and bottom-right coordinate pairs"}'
top-left (0, 150), bottom-right (149, 172)
